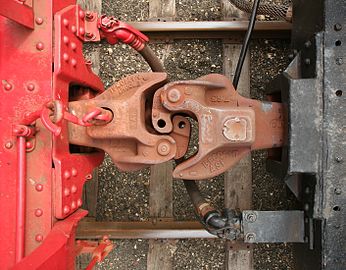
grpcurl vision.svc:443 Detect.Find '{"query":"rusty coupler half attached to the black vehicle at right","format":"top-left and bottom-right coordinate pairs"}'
top-left (161, 74), bottom-right (284, 180)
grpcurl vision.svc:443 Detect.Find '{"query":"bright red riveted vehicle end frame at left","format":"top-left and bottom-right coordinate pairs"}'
top-left (0, 0), bottom-right (109, 269)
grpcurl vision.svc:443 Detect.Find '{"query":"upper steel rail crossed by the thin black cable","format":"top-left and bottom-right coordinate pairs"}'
top-left (129, 21), bottom-right (292, 39)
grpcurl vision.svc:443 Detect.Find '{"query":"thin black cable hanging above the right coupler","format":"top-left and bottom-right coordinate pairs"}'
top-left (233, 0), bottom-right (260, 89)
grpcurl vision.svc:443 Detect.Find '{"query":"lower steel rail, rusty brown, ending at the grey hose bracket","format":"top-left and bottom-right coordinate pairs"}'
top-left (76, 219), bottom-right (215, 239)
